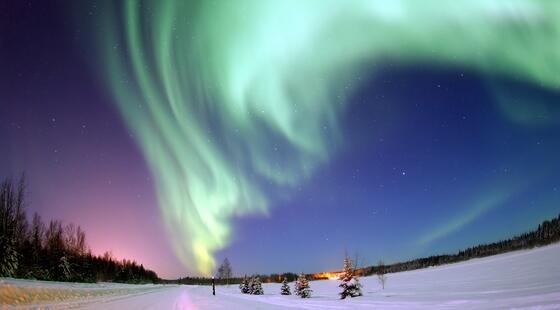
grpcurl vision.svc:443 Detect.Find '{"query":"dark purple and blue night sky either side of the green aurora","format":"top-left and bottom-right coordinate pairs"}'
top-left (0, 1), bottom-right (560, 277)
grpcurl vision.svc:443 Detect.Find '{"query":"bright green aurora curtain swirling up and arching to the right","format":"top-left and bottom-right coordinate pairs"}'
top-left (96, 0), bottom-right (560, 275)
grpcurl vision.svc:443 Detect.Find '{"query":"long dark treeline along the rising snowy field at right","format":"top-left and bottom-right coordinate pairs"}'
top-left (357, 215), bottom-right (560, 275)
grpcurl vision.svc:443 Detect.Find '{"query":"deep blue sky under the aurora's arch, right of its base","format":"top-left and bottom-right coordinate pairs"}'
top-left (223, 64), bottom-right (560, 271)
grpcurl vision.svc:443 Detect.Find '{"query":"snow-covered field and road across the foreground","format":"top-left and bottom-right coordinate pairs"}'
top-left (0, 244), bottom-right (560, 310)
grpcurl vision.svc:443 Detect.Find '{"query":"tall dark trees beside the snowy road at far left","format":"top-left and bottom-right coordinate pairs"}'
top-left (0, 178), bottom-right (159, 283)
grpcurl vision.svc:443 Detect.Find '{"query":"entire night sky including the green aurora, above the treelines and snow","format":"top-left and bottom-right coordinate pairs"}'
top-left (0, 0), bottom-right (560, 278)
